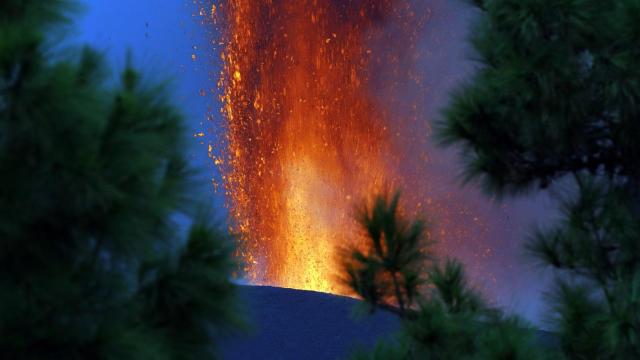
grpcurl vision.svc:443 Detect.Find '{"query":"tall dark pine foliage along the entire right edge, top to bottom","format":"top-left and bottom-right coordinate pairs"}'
top-left (439, 0), bottom-right (640, 359)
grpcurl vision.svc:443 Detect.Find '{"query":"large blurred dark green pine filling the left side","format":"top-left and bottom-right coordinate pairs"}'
top-left (0, 0), bottom-right (237, 359)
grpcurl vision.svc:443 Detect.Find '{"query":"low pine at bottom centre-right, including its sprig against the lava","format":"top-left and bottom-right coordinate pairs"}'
top-left (343, 193), bottom-right (543, 359)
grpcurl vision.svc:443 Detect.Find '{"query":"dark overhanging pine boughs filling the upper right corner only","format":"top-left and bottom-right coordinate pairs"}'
top-left (439, 0), bottom-right (640, 197)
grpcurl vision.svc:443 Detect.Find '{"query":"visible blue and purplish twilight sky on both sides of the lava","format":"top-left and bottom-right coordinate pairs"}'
top-left (74, 0), bottom-right (553, 324)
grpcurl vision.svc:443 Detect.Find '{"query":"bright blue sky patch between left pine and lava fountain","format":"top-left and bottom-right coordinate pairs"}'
top-left (74, 0), bottom-right (224, 208)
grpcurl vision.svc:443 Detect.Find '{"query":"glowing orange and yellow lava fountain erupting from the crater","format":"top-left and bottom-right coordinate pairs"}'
top-left (218, 0), bottom-right (428, 293)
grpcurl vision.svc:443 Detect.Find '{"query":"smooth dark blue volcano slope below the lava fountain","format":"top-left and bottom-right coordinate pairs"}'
top-left (219, 286), bottom-right (558, 360)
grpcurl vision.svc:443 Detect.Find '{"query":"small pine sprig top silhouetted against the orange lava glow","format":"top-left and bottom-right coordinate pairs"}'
top-left (343, 193), bottom-right (430, 317)
